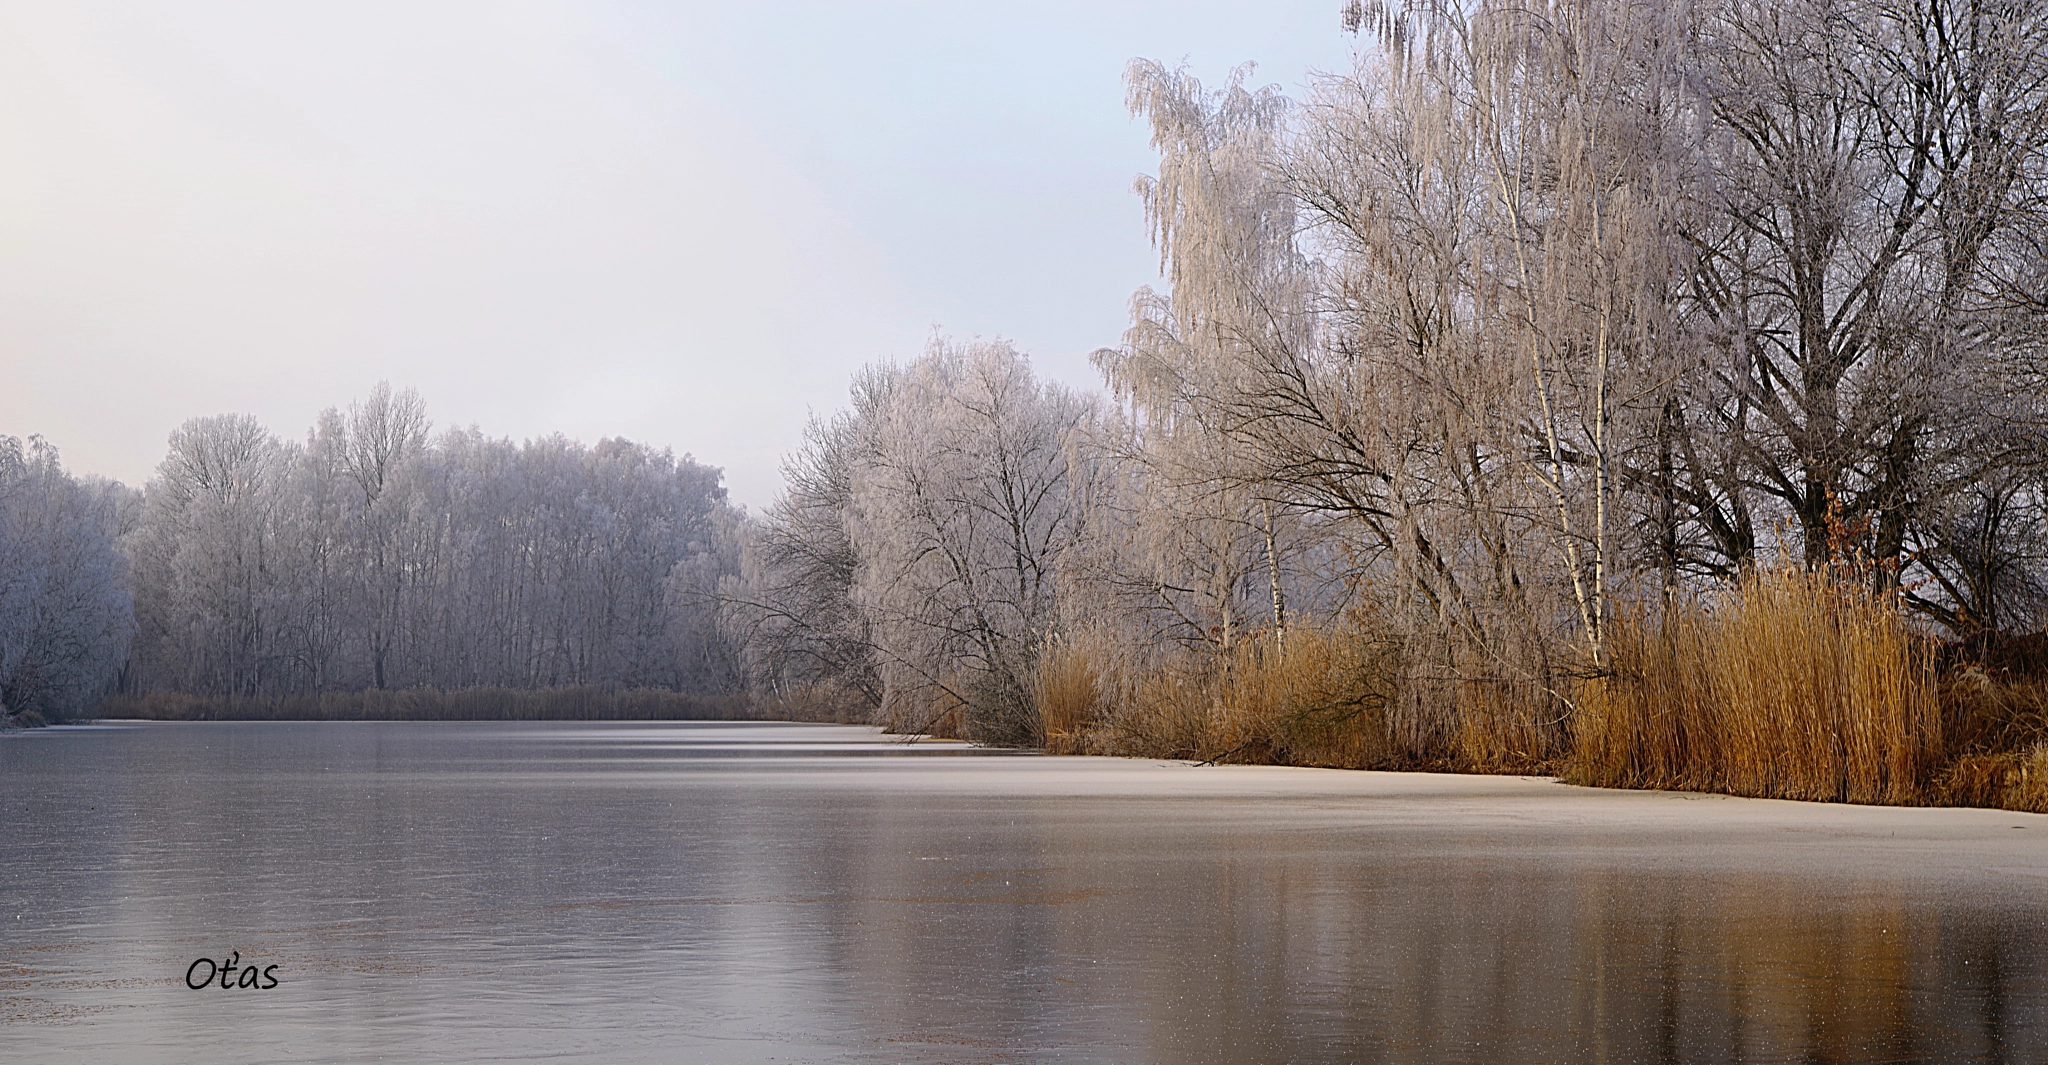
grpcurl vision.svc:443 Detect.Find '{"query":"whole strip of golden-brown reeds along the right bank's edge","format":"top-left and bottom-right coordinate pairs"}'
top-left (1032, 567), bottom-right (2048, 813)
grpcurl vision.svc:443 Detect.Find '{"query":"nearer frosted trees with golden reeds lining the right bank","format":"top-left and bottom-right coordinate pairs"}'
top-left (725, 0), bottom-right (2048, 803)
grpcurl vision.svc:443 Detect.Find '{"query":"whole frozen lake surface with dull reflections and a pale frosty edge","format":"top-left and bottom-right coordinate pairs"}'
top-left (0, 723), bottom-right (2048, 1065)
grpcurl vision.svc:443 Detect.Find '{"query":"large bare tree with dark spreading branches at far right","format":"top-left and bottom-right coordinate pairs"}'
top-left (1675, 0), bottom-right (2048, 567)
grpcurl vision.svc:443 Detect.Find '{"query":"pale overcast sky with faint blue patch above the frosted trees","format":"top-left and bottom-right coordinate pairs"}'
top-left (0, 0), bottom-right (1352, 510)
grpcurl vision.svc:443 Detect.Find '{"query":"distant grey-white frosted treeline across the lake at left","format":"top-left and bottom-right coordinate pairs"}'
top-left (0, 385), bottom-right (741, 719)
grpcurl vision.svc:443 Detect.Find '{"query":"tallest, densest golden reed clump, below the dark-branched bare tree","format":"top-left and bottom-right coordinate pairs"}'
top-left (1565, 567), bottom-right (1944, 803)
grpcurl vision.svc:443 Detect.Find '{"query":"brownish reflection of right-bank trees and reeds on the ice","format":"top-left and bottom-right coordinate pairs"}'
top-left (802, 786), bottom-right (2048, 1065)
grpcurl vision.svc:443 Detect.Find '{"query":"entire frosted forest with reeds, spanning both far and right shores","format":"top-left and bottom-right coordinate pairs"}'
top-left (12, 0), bottom-right (2048, 811)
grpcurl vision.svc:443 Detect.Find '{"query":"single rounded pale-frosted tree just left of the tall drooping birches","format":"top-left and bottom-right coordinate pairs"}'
top-left (848, 342), bottom-right (1098, 743)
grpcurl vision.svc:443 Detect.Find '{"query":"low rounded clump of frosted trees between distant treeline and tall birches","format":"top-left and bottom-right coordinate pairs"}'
top-left (723, 340), bottom-right (1102, 743)
